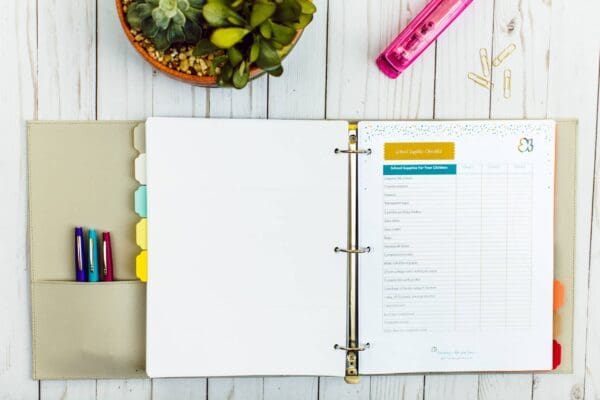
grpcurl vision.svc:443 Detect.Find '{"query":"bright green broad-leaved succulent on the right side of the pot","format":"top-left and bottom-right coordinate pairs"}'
top-left (196, 0), bottom-right (316, 88)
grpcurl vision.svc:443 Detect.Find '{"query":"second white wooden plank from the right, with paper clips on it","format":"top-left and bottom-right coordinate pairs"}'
top-left (479, 0), bottom-right (550, 399)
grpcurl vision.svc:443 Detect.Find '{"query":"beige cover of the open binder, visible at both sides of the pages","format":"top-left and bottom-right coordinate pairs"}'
top-left (28, 121), bottom-right (577, 379)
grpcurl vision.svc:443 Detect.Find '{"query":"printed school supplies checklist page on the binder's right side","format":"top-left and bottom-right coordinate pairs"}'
top-left (358, 121), bottom-right (555, 374)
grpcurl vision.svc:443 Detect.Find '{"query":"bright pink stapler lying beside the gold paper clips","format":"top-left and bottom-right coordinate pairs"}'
top-left (377, 0), bottom-right (473, 79)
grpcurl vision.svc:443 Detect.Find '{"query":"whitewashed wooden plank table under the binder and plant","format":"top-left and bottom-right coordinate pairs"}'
top-left (0, 0), bottom-right (600, 400)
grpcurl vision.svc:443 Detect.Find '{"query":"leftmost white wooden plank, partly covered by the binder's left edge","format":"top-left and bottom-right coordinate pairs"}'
top-left (0, 0), bottom-right (39, 399)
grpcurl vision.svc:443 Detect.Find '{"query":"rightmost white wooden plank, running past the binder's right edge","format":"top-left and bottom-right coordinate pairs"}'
top-left (552, 0), bottom-right (600, 400)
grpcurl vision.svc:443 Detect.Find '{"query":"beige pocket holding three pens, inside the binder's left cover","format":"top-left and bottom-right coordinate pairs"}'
top-left (32, 281), bottom-right (146, 379)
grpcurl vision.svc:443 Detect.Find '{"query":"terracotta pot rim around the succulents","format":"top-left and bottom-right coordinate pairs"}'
top-left (115, 0), bottom-right (303, 87)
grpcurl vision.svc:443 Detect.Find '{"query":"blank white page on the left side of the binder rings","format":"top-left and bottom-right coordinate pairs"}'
top-left (146, 118), bottom-right (348, 377)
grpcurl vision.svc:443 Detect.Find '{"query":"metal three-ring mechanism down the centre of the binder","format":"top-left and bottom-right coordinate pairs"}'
top-left (333, 124), bottom-right (371, 383)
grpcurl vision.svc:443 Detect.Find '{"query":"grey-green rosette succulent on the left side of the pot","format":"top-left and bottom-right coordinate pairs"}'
top-left (127, 0), bottom-right (205, 50)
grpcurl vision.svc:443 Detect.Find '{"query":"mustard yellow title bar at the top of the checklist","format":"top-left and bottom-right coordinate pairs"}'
top-left (383, 142), bottom-right (454, 160)
